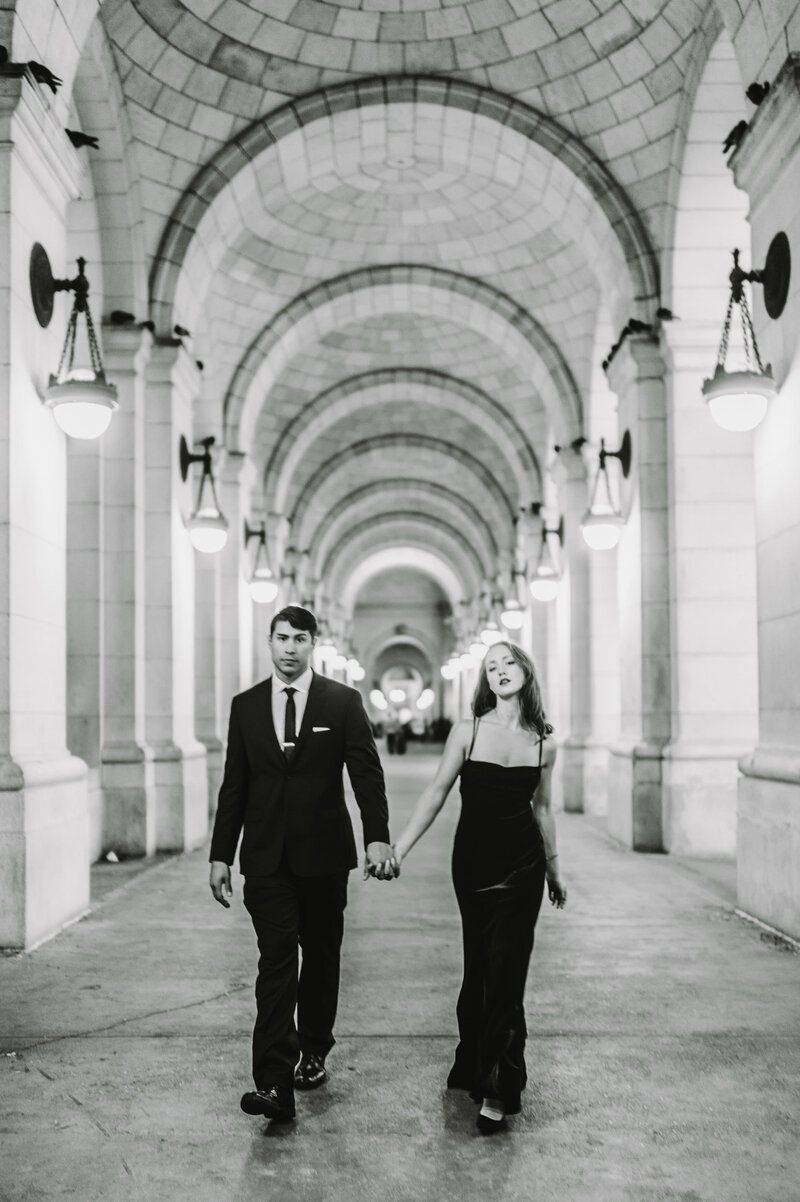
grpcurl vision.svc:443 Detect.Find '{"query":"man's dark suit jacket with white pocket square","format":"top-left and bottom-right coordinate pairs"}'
top-left (209, 672), bottom-right (389, 876)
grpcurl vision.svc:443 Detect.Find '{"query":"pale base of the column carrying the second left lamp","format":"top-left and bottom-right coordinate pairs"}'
top-left (153, 743), bottom-right (208, 851)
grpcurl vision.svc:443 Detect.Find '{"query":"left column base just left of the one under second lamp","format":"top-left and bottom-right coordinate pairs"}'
top-left (101, 743), bottom-right (156, 856)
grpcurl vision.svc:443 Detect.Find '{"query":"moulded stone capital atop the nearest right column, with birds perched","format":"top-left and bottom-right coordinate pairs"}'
top-left (728, 53), bottom-right (800, 203)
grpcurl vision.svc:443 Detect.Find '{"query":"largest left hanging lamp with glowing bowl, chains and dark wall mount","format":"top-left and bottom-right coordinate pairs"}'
top-left (30, 251), bottom-right (119, 439)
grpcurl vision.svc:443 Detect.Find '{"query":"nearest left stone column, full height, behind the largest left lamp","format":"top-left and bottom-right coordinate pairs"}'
top-left (0, 76), bottom-right (89, 948)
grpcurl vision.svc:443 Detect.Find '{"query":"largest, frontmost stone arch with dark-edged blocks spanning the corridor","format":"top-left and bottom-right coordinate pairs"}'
top-left (150, 76), bottom-right (659, 341)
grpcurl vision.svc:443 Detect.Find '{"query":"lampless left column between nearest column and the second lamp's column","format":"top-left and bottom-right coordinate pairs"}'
top-left (101, 326), bottom-right (156, 856)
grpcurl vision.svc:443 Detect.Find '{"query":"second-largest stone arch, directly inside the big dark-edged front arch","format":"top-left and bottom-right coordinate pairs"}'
top-left (236, 264), bottom-right (583, 447)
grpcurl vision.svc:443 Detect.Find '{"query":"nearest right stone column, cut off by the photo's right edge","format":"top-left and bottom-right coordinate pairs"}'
top-left (732, 54), bottom-right (800, 936)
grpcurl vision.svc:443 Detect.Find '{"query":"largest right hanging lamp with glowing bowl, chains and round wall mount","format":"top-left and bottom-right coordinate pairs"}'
top-left (703, 232), bottom-right (792, 432)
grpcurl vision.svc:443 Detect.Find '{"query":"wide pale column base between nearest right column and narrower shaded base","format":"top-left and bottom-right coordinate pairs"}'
top-left (662, 743), bottom-right (740, 859)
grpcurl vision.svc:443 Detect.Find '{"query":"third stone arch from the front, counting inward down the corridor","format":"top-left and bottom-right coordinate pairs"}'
top-left (264, 368), bottom-right (542, 513)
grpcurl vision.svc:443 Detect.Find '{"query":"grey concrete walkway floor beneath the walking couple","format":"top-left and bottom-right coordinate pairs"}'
top-left (0, 756), bottom-right (800, 1202)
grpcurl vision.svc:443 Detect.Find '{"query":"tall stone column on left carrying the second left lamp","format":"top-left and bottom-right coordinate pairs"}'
top-left (144, 345), bottom-right (208, 851)
